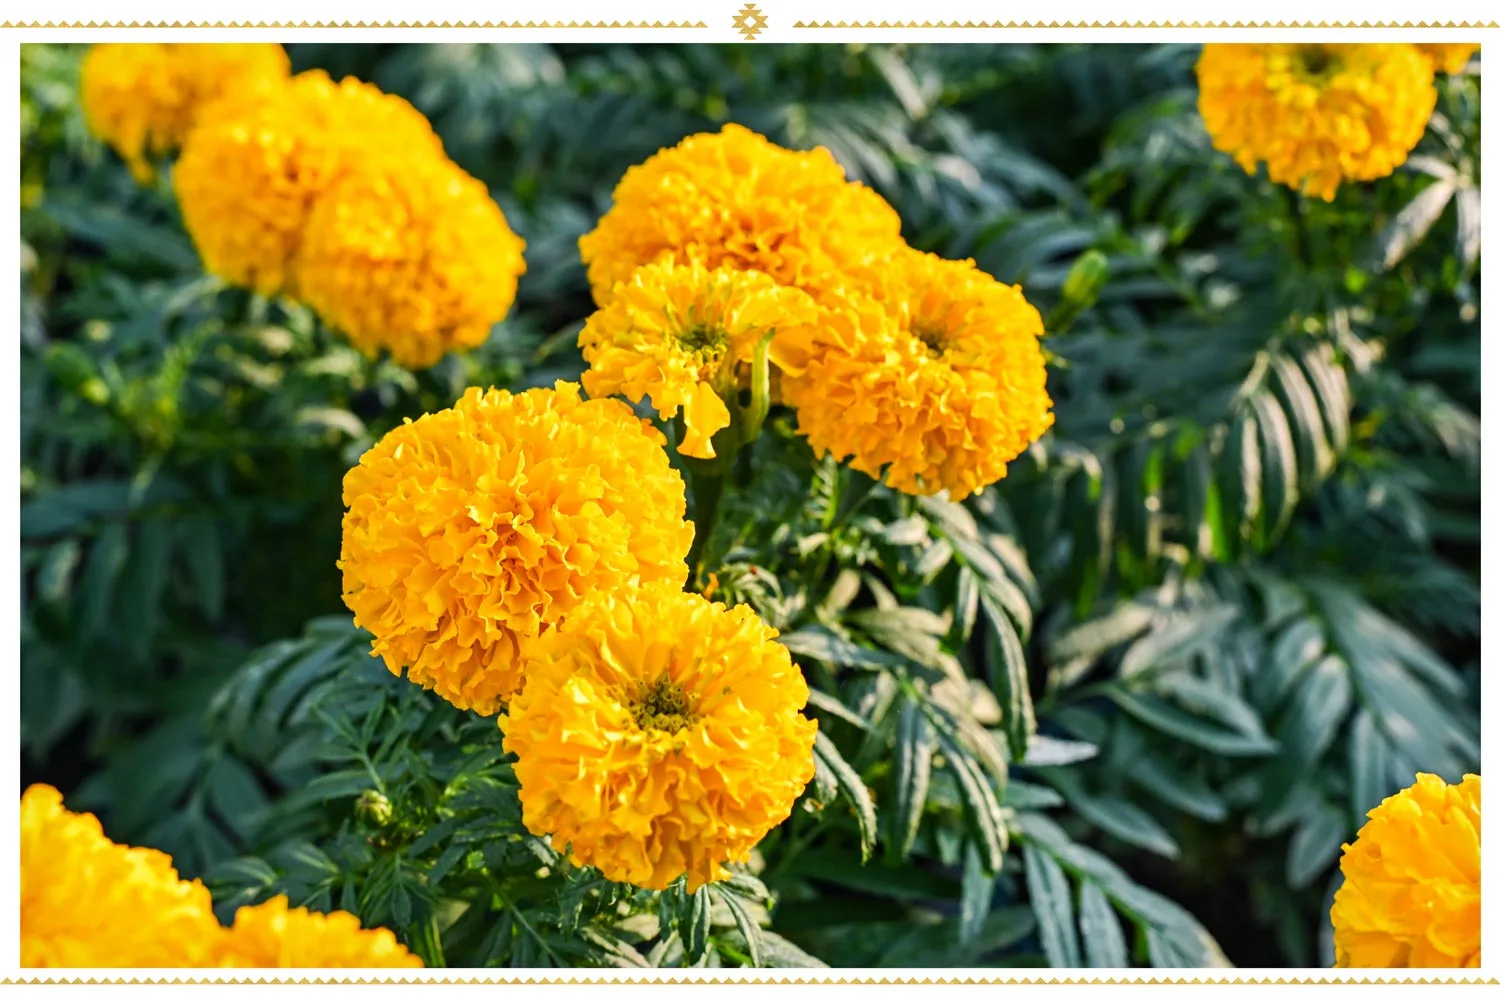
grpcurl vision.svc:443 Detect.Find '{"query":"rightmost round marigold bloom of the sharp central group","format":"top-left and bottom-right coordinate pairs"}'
top-left (771, 251), bottom-right (1053, 501)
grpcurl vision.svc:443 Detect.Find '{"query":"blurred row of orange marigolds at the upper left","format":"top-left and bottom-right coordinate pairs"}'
top-left (80, 44), bottom-right (525, 369)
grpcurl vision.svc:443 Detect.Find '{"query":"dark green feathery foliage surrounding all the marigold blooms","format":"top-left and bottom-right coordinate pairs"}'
top-left (21, 45), bottom-right (1479, 966)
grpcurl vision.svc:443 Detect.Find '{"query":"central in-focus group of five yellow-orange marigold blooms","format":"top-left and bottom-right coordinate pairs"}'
top-left (341, 125), bottom-right (1052, 890)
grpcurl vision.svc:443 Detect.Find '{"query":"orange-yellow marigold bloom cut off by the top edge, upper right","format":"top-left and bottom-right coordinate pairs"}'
top-left (1199, 45), bottom-right (1437, 201)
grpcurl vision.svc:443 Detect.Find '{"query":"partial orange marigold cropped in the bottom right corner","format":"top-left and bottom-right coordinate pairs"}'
top-left (1332, 774), bottom-right (1481, 968)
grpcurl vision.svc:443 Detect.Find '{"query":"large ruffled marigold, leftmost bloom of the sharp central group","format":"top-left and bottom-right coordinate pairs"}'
top-left (339, 381), bottom-right (693, 714)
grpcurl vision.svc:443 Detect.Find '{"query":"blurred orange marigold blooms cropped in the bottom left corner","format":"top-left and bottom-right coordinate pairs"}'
top-left (21, 785), bottom-right (423, 968)
